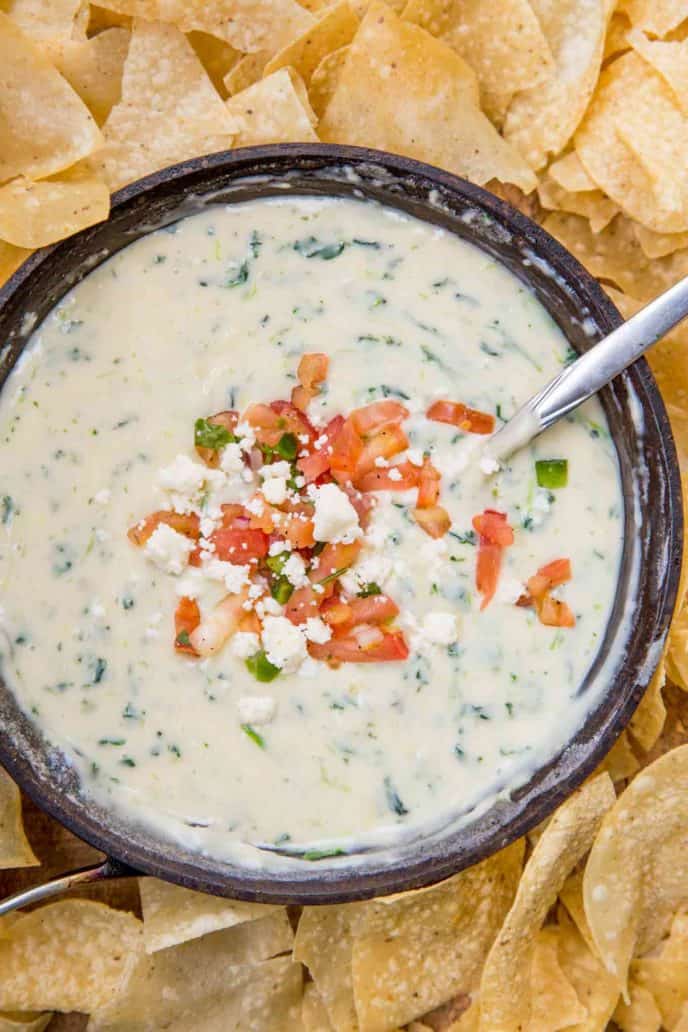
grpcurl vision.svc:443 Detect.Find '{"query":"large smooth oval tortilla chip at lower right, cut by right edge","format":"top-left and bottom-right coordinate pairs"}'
top-left (583, 745), bottom-right (688, 993)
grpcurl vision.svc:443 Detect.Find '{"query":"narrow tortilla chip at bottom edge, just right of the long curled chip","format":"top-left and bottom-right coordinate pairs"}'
top-left (528, 928), bottom-right (588, 1032)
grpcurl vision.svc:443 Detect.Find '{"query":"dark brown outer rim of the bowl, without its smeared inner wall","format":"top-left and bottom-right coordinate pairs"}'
top-left (0, 143), bottom-right (683, 904)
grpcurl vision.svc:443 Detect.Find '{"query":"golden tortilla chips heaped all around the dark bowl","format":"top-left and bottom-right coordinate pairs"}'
top-left (0, 0), bottom-right (688, 1032)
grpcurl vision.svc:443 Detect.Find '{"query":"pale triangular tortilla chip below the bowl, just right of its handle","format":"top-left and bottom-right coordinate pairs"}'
top-left (138, 878), bottom-right (285, 954)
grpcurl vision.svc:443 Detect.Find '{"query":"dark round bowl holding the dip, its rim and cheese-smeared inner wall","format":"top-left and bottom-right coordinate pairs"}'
top-left (0, 144), bottom-right (683, 904)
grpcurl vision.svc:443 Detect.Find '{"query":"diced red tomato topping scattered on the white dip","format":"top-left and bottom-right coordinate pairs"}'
top-left (129, 354), bottom-right (575, 666)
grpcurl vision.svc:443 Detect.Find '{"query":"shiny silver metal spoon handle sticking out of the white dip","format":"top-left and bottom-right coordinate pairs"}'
top-left (481, 277), bottom-right (688, 473)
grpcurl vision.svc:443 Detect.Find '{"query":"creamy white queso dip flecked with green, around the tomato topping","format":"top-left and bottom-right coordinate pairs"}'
top-left (0, 198), bottom-right (623, 860)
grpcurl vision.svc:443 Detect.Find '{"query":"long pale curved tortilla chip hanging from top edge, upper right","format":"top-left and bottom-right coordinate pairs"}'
top-left (504, 0), bottom-right (608, 171)
